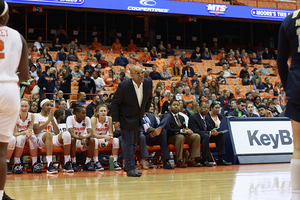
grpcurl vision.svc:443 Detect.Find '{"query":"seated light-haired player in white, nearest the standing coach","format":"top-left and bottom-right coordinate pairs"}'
top-left (91, 104), bottom-right (121, 170)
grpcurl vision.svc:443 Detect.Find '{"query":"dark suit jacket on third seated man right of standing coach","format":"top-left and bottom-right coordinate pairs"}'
top-left (189, 112), bottom-right (214, 136)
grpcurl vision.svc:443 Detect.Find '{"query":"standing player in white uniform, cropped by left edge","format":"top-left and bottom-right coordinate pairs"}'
top-left (0, 0), bottom-right (29, 199)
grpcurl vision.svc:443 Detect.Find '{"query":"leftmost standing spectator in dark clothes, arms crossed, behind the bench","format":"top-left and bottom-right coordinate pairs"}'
top-left (38, 66), bottom-right (55, 99)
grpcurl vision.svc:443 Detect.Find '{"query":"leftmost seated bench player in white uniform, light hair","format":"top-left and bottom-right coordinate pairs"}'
top-left (7, 98), bottom-right (42, 174)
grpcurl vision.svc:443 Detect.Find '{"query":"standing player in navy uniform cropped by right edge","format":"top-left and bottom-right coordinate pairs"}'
top-left (277, 10), bottom-right (300, 200)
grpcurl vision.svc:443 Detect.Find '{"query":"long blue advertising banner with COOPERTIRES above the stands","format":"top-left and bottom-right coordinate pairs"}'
top-left (6, 0), bottom-right (293, 21)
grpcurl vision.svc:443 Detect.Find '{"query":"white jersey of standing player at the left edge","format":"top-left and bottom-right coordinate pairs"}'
top-left (0, 26), bottom-right (23, 83)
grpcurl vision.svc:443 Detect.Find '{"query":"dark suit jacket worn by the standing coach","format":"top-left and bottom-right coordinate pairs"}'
top-left (111, 78), bottom-right (152, 131)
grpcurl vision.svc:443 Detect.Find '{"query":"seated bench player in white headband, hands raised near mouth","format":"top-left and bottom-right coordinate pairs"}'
top-left (33, 99), bottom-right (74, 174)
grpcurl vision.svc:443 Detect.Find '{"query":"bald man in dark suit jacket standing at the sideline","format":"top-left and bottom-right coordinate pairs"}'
top-left (111, 66), bottom-right (152, 177)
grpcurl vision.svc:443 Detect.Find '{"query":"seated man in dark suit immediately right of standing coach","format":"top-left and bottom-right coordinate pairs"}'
top-left (142, 103), bottom-right (174, 169)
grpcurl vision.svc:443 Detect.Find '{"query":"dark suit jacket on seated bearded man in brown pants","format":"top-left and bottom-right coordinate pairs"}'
top-left (161, 111), bottom-right (186, 140)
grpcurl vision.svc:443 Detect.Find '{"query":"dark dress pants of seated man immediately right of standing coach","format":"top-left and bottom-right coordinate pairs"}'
top-left (146, 129), bottom-right (170, 160)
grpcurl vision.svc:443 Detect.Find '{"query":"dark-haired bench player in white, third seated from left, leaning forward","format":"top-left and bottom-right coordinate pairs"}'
top-left (66, 105), bottom-right (95, 172)
